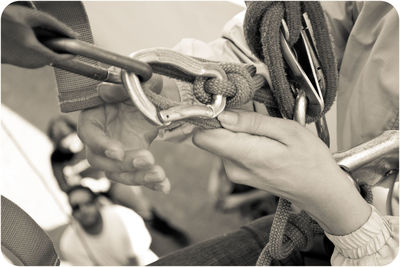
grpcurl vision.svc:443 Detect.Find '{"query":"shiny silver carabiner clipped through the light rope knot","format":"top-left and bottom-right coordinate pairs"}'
top-left (121, 48), bottom-right (227, 126)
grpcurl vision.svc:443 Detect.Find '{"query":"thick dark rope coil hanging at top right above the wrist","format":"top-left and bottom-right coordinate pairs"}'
top-left (243, 1), bottom-right (337, 122)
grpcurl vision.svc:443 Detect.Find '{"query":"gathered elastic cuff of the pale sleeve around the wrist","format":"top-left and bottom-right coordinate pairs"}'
top-left (325, 205), bottom-right (391, 259)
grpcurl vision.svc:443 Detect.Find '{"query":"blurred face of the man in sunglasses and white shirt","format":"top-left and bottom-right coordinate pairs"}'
top-left (69, 190), bottom-right (100, 227)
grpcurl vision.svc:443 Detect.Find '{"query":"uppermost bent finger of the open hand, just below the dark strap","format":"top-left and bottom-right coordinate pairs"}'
top-left (78, 107), bottom-right (125, 161)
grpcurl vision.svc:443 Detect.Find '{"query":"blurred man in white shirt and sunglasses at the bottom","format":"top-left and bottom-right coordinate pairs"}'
top-left (60, 186), bottom-right (158, 265)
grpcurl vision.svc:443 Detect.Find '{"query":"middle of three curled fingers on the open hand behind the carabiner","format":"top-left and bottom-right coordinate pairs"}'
top-left (86, 147), bottom-right (155, 172)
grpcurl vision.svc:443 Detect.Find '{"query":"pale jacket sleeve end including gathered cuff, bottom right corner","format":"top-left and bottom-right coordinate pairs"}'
top-left (325, 206), bottom-right (399, 266)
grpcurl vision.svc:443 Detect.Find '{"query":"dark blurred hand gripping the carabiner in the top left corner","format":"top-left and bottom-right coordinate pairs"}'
top-left (1, 5), bottom-right (77, 68)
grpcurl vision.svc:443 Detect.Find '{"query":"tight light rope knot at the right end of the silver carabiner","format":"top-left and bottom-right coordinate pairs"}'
top-left (193, 63), bottom-right (256, 107)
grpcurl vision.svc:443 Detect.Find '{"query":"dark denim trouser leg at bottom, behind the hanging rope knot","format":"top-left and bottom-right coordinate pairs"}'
top-left (151, 215), bottom-right (333, 266)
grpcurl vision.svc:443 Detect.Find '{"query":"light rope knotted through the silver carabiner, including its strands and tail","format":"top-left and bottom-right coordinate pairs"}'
top-left (143, 62), bottom-right (277, 128)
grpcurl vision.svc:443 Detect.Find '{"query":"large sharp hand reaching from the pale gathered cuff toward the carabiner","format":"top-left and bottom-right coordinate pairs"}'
top-left (193, 112), bottom-right (371, 234)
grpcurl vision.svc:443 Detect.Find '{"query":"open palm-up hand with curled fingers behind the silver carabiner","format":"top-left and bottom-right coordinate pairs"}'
top-left (78, 75), bottom-right (171, 193)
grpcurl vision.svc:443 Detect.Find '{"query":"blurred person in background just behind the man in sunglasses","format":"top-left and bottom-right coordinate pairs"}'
top-left (48, 116), bottom-right (190, 246)
